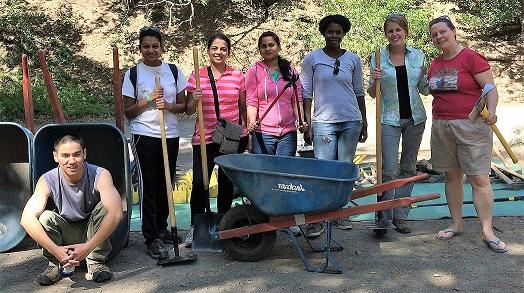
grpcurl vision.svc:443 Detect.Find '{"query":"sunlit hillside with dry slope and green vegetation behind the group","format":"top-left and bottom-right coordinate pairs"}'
top-left (0, 0), bottom-right (524, 121)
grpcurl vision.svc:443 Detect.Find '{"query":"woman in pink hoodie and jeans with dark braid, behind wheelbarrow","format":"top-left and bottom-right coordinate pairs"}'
top-left (246, 32), bottom-right (307, 156)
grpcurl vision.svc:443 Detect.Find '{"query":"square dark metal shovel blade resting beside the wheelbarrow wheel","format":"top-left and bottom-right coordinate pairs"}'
top-left (192, 213), bottom-right (222, 252)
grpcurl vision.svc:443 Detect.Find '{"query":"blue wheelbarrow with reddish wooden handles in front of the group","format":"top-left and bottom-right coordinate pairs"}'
top-left (215, 154), bottom-right (440, 273)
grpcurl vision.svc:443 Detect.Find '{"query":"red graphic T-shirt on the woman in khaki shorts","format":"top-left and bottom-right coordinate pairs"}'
top-left (428, 48), bottom-right (490, 120)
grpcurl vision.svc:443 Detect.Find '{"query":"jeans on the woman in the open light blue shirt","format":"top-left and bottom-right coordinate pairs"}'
top-left (378, 119), bottom-right (426, 222)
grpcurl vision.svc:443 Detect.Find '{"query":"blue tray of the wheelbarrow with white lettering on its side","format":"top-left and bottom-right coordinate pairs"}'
top-left (215, 154), bottom-right (358, 216)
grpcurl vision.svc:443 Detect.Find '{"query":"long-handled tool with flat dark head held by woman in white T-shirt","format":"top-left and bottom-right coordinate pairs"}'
top-left (155, 75), bottom-right (196, 266)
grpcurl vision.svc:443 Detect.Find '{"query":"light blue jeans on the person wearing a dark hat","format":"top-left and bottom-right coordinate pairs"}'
top-left (313, 121), bottom-right (362, 162)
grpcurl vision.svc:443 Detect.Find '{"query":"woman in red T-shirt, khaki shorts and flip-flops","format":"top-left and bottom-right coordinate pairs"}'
top-left (428, 16), bottom-right (507, 252)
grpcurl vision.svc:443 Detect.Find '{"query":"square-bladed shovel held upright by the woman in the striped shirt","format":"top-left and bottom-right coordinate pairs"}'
top-left (192, 47), bottom-right (222, 252)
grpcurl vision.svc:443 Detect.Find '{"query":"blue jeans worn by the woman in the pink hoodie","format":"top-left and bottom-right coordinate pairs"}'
top-left (252, 131), bottom-right (297, 156)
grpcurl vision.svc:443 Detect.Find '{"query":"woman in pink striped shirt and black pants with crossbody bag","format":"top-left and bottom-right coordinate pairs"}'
top-left (185, 33), bottom-right (248, 247)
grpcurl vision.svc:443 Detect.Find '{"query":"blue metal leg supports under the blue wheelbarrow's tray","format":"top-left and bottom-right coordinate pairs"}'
top-left (282, 221), bottom-right (343, 274)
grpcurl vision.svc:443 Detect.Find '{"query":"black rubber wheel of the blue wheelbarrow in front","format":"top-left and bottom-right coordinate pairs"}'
top-left (220, 204), bottom-right (276, 262)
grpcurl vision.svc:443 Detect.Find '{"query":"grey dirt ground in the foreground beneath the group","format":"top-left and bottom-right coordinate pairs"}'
top-left (0, 217), bottom-right (524, 292)
